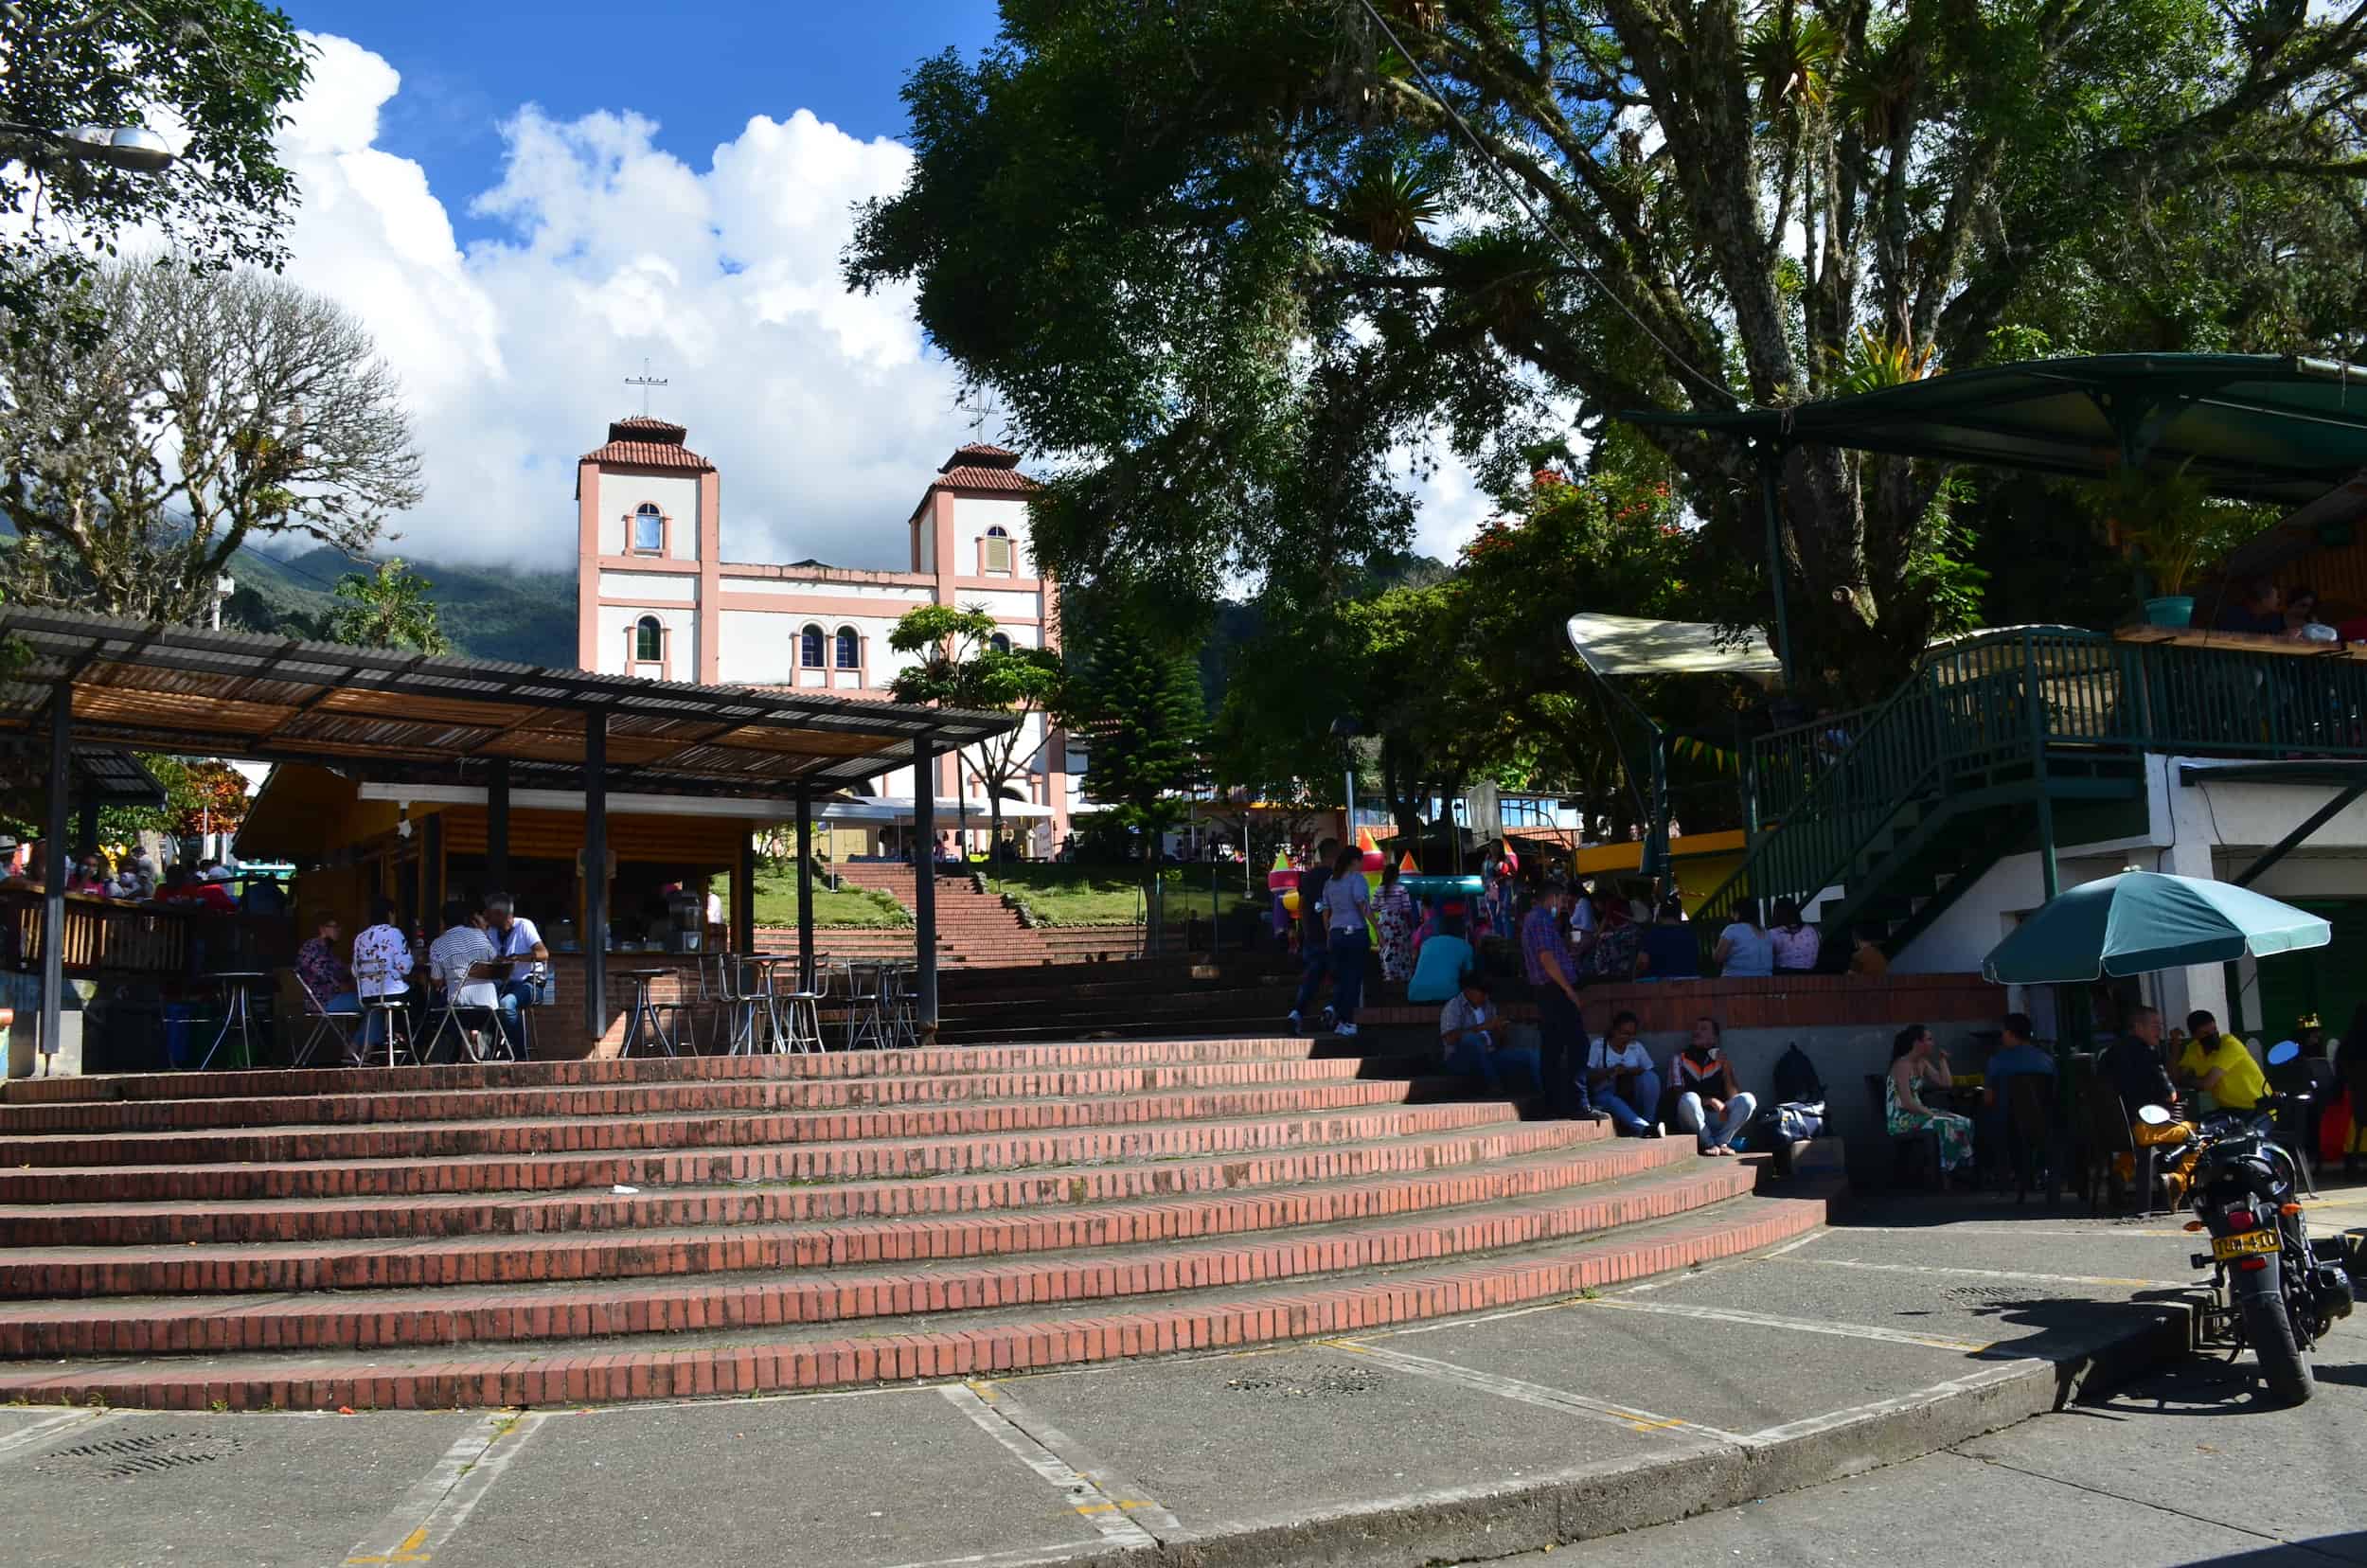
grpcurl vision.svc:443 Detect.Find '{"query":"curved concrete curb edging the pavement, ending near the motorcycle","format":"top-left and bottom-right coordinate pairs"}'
top-left (1027, 1300), bottom-right (2195, 1568)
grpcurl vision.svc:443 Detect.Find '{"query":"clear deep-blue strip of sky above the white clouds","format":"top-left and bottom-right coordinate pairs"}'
top-left (282, 0), bottom-right (997, 244)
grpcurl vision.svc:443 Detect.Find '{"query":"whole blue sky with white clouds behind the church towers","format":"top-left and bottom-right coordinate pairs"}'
top-left (258, 0), bottom-right (1485, 568)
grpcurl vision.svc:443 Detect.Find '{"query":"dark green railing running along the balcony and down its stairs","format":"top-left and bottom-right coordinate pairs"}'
top-left (1695, 628), bottom-right (2367, 956)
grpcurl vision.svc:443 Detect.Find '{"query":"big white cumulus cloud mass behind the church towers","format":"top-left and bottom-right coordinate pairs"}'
top-left (282, 36), bottom-right (970, 566)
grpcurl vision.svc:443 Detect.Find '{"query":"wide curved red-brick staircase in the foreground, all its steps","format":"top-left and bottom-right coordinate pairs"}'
top-left (0, 1038), bottom-right (1830, 1409)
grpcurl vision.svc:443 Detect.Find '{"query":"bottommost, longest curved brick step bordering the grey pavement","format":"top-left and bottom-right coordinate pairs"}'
top-left (0, 1186), bottom-right (1827, 1409)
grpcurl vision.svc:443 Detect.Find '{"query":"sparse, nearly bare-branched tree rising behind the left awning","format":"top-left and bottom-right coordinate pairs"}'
top-left (0, 260), bottom-right (421, 620)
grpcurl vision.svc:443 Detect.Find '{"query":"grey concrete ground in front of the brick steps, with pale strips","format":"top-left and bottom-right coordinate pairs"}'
top-left (0, 1191), bottom-right (2367, 1568)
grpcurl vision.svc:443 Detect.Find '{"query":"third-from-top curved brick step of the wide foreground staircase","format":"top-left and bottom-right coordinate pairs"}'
top-left (0, 1085), bottom-right (1520, 1203)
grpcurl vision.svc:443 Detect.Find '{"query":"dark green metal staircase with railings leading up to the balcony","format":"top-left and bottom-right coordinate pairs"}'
top-left (1695, 628), bottom-right (2367, 971)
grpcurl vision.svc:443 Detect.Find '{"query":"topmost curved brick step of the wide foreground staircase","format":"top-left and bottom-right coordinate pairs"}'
top-left (0, 1035), bottom-right (1307, 1106)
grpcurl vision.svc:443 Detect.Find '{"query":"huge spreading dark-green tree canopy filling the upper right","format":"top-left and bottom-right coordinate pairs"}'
top-left (847, 0), bottom-right (2367, 686)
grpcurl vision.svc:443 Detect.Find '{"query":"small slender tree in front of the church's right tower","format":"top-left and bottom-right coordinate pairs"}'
top-left (888, 604), bottom-right (1060, 855)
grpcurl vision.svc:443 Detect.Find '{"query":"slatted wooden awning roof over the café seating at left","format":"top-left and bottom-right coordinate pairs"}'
top-left (0, 606), bottom-right (1018, 798)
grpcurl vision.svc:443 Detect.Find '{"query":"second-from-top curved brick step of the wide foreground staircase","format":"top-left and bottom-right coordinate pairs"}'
top-left (0, 1057), bottom-right (1378, 1137)
